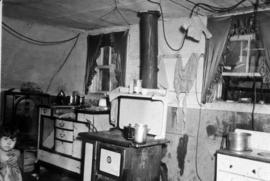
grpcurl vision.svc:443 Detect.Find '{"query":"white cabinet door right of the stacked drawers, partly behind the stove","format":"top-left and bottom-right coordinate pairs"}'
top-left (72, 123), bottom-right (89, 158)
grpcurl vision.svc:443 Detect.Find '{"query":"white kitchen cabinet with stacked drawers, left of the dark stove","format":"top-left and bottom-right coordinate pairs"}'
top-left (38, 106), bottom-right (110, 174)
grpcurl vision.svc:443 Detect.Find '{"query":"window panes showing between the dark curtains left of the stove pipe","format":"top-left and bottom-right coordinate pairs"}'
top-left (89, 46), bottom-right (118, 92)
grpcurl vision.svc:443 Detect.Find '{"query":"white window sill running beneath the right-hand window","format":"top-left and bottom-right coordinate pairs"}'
top-left (203, 101), bottom-right (270, 114)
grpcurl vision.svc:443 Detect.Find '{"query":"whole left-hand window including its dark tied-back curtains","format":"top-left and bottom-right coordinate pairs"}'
top-left (84, 30), bottom-right (128, 94)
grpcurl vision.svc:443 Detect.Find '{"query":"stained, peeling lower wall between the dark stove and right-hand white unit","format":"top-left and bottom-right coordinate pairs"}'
top-left (163, 107), bottom-right (270, 181)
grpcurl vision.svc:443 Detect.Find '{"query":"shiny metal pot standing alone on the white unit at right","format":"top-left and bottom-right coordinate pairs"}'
top-left (227, 132), bottom-right (251, 151)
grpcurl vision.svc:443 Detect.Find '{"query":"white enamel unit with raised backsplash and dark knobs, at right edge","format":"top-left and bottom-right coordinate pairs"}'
top-left (216, 129), bottom-right (270, 181)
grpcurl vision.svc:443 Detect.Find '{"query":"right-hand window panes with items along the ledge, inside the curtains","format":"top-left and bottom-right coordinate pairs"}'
top-left (222, 34), bottom-right (269, 103)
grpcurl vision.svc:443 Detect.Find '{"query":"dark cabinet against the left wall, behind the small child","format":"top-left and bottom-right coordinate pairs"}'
top-left (3, 91), bottom-right (50, 149)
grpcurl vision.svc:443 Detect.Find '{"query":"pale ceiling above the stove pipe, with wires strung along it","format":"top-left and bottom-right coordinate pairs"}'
top-left (3, 0), bottom-right (269, 30)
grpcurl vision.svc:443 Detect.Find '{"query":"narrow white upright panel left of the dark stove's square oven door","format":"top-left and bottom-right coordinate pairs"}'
top-left (83, 142), bottom-right (94, 181)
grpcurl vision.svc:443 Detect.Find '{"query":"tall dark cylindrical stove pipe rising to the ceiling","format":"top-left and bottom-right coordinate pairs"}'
top-left (138, 11), bottom-right (160, 88)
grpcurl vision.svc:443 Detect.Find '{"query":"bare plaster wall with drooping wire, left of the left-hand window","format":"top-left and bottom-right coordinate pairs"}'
top-left (1, 18), bottom-right (86, 95)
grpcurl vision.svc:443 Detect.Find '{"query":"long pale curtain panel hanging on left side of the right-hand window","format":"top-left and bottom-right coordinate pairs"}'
top-left (202, 17), bottom-right (231, 103)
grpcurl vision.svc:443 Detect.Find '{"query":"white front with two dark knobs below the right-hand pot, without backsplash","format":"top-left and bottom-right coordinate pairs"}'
top-left (216, 152), bottom-right (270, 181)
